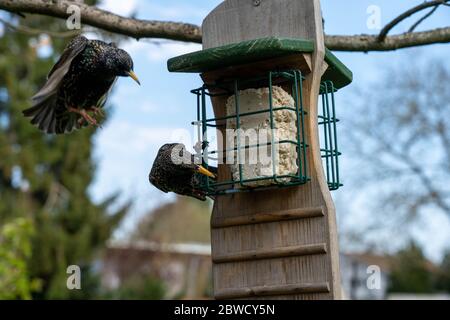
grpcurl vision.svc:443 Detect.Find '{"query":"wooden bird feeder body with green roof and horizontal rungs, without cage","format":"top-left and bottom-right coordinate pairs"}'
top-left (168, 0), bottom-right (351, 299)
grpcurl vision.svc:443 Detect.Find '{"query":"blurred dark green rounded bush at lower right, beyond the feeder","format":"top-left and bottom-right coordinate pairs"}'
top-left (388, 242), bottom-right (436, 293)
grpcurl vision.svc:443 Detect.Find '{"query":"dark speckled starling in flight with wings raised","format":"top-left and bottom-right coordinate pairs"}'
top-left (23, 36), bottom-right (139, 134)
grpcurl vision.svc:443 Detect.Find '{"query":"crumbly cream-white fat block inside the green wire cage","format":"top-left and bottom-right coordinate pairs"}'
top-left (226, 86), bottom-right (298, 187)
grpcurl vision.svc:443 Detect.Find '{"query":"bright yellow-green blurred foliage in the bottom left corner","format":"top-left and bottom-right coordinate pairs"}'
top-left (0, 218), bottom-right (40, 300)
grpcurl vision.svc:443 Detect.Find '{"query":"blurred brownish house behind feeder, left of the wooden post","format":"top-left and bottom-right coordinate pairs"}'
top-left (100, 241), bottom-right (211, 299)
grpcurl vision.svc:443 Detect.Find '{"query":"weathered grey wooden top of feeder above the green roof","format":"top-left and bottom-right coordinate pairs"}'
top-left (202, 0), bottom-right (322, 49)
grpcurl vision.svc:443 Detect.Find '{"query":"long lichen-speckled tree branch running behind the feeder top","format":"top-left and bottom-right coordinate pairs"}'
top-left (0, 0), bottom-right (450, 52)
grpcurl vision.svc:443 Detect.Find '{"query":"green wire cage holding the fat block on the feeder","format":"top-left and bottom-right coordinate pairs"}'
top-left (191, 70), bottom-right (342, 195)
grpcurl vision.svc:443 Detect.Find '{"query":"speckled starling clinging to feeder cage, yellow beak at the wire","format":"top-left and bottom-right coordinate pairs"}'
top-left (149, 143), bottom-right (217, 200)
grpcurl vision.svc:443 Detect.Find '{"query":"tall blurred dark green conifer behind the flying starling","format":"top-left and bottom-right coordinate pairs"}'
top-left (0, 5), bottom-right (126, 298)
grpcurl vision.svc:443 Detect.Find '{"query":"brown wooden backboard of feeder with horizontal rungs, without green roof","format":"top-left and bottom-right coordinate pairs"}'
top-left (202, 0), bottom-right (341, 299)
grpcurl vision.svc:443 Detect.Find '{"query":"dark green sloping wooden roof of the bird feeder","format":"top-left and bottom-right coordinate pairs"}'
top-left (167, 37), bottom-right (353, 89)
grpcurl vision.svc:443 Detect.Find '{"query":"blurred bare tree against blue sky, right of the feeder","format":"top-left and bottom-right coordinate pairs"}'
top-left (342, 58), bottom-right (450, 249)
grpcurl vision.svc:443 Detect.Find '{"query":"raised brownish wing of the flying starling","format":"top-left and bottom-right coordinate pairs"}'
top-left (31, 36), bottom-right (89, 105)
